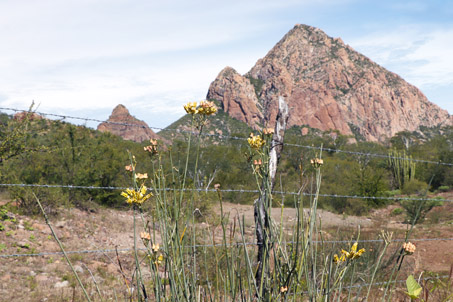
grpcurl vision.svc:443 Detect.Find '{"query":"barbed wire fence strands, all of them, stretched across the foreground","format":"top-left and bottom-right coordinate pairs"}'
top-left (0, 107), bottom-right (453, 289)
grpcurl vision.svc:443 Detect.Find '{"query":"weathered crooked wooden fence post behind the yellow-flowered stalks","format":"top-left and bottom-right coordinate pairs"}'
top-left (254, 96), bottom-right (289, 300)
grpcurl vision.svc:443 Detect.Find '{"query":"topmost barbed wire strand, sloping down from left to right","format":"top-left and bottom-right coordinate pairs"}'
top-left (0, 107), bottom-right (453, 166)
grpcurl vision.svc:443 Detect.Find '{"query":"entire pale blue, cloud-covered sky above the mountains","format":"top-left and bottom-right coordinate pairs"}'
top-left (0, 0), bottom-right (453, 127)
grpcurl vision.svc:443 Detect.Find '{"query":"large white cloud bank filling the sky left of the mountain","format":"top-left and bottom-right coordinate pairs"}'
top-left (0, 0), bottom-right (282, 123)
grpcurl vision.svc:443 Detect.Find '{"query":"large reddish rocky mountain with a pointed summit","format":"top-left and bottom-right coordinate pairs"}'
top-left (207, 25), bottom-right (452, 141)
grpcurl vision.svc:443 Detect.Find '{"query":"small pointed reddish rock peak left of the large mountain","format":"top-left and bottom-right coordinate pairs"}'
top-left (97, 104), bottom-right (160, 142)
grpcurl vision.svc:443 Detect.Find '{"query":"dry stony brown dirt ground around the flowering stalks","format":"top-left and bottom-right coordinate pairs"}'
top-left (0, 193), bottom-right (453, 301)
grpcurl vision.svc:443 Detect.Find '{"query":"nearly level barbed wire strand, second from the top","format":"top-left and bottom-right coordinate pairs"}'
top-left (0, 183), bottom-right (453, 202)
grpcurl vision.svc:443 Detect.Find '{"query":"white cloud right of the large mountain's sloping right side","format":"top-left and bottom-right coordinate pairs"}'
top-left (350, 24), bottom-right (453, 113)
